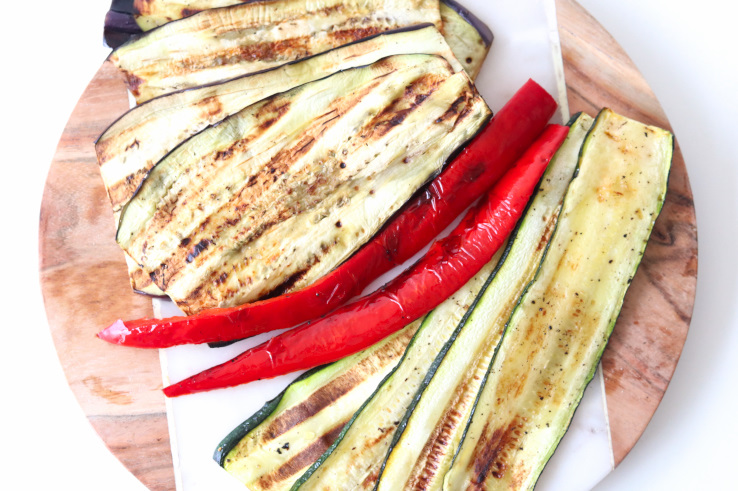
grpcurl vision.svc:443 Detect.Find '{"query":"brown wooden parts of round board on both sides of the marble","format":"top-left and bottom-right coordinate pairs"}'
top-left (39, 0), bottom-right (697, 491)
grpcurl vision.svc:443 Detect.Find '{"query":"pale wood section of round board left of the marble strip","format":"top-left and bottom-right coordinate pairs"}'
top-left (39, 63), bottom-right (174, 491)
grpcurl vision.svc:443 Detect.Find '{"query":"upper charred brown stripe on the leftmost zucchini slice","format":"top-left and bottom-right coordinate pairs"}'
top-left (261, 330), bottom-right (415, 443)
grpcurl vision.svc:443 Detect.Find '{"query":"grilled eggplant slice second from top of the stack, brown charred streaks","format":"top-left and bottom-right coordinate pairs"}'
top-left (109, 0), bottom-right (441, 103)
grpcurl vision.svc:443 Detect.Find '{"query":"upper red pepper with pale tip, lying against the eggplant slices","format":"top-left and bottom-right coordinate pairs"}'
top-left (98, 80), bottom-right (556, 348)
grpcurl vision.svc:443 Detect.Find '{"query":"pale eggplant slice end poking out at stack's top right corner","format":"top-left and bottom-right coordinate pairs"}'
top-left (440, 0), bottom-right (494, 79)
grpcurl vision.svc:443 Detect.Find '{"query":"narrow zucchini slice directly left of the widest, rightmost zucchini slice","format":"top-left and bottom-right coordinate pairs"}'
top-left (378, 116), bottom-right (592, 490)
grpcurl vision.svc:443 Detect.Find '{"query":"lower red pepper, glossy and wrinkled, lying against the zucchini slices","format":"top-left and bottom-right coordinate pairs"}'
top-left (164, 125), bottom-right (569, 397)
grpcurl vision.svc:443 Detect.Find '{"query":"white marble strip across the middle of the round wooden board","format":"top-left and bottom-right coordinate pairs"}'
top-left (154, 0), bottom-right (613, 491)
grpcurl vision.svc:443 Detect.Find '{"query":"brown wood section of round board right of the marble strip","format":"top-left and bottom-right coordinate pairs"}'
top-left (556, 0), bottom-right (697, 465)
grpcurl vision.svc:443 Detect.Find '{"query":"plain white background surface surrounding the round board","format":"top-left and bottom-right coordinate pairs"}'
top-left (0, 0), bottom-right (738, 491)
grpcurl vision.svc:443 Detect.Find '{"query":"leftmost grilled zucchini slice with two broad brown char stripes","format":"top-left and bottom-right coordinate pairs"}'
top-left (214, 320), bottom-right (421, 491)
